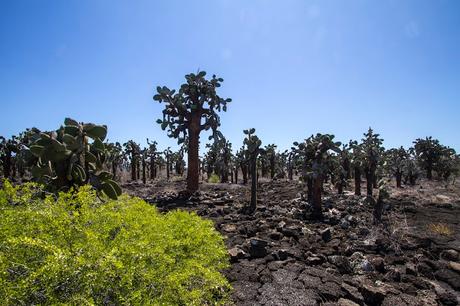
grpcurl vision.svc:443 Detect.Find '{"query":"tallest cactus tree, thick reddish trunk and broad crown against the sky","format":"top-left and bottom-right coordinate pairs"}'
top-left (153, 71), bottom-right (231, 192)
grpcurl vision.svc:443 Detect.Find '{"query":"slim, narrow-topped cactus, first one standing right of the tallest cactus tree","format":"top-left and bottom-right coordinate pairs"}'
top-left (243, 128), bottom-right (262, 213)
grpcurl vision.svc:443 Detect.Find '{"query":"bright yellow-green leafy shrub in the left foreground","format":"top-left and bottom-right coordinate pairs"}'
top-left (0, 182), bottom-right (230, 305)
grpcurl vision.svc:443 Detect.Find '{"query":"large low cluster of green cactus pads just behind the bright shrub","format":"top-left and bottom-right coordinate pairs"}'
top-left (29, 118), bottom-right (121, 199)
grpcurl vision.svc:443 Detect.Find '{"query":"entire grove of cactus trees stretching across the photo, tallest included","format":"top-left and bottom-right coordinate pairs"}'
top-left (0, 71), bottom-right (460, 222)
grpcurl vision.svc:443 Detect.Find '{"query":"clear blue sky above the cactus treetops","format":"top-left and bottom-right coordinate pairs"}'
top-left (0, 0), bottom-right (460, 151)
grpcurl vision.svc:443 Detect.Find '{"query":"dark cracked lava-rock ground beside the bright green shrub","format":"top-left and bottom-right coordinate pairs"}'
top-left (123, 181), bottom-right (460, 306)
